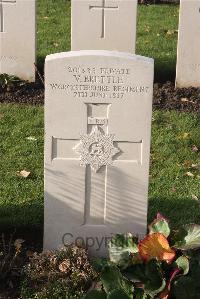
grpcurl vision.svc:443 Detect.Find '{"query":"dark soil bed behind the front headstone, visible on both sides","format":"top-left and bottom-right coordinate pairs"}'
top-left (0, 81), bottom-right (200, 113)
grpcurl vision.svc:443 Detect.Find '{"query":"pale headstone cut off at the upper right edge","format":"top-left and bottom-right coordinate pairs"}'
top-left (176, 0), bottom-right (200, 87)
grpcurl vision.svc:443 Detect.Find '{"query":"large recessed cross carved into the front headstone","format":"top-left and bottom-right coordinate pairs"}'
top-left (52, 104), bottom-right (142, 225)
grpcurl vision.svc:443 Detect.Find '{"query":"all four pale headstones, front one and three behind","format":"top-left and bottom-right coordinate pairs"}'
top-left (0, 0), bottom-right (200, 255)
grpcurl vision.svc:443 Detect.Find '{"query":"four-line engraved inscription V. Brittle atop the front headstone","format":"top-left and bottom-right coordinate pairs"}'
top-left (50, 66), bottom-right (150, 100)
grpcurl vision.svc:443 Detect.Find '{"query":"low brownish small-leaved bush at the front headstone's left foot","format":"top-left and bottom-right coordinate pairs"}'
top-left (21, 246), bottom-right (97, 299)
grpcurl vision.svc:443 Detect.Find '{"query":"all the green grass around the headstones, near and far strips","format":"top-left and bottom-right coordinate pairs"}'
top-left (0, 0), bottom-right (200, 234)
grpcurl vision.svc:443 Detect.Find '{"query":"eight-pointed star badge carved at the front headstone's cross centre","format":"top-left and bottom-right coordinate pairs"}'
top-left (74, 126), bottom-right (120, 172)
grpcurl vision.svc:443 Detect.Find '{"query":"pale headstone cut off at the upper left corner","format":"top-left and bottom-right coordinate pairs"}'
top-left (0, 0), bottom-right (35, 81)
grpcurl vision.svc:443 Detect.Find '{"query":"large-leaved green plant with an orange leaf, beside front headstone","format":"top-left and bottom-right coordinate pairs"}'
top-left (86, 214), bottom-right (200, 299)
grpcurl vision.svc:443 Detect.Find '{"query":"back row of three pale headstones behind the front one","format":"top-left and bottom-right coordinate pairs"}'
top-left (0, 0), bottom-right (200, 87)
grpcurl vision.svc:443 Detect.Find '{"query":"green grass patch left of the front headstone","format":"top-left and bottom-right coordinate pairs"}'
top-left (0, 105), bottom-right (44, 227)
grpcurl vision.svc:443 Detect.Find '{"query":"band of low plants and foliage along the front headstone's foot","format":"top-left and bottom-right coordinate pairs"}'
top-left (0, 214), bottom-right (200, 299)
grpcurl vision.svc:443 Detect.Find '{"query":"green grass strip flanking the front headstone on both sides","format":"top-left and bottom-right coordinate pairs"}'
top-left (0, 104), bottom-right (200, 231)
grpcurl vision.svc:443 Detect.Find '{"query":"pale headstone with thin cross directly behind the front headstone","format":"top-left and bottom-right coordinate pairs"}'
top-left (71, 0), bottom-right (137, 53)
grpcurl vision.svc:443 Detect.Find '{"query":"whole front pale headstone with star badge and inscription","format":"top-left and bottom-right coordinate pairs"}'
top-left (44, 51), bottom-right (153, 255)
